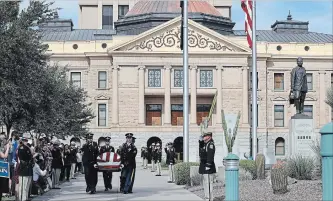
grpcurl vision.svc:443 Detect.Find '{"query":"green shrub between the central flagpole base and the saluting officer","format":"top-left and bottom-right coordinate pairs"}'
top-left (174, 162), bottom-right (199, 185)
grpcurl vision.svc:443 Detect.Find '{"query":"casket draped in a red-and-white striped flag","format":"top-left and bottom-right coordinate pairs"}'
top-left (97, 152), bottom-right (120, 172)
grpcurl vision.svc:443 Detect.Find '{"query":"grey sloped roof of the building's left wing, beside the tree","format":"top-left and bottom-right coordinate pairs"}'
top-left (41, 29), bottom-right (116, 41)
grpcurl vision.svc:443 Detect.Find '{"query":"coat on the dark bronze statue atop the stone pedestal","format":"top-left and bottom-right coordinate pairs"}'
top-left (290, 66), bottom-right (308, 93)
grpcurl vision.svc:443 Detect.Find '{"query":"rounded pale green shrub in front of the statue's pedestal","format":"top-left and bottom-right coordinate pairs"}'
top-left (287, 155), bottom-right (315, 180)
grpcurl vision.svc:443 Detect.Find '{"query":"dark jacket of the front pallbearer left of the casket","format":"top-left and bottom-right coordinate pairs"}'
top-left (82, 142), bottom-right (99, 166)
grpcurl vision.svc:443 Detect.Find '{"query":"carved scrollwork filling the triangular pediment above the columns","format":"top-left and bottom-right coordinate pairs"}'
top-left (127, 27), bottom-right (235, 52)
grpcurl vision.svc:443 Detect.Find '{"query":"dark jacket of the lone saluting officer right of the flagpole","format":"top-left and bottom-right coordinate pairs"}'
top-left (199, 140), bottom-right (216, 174)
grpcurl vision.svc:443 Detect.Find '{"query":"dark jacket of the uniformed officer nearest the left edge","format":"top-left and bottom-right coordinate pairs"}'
top-left (18, 145), bottom-right (33, 176)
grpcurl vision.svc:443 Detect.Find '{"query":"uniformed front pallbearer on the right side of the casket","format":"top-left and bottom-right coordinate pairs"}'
top-left (121, 133), bottom-right (138, 194)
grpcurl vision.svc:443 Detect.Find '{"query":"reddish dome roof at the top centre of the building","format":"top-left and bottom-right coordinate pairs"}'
top-left (126, 0), bottom-right (221, 16)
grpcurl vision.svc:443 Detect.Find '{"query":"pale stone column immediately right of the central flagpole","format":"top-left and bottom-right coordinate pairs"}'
top-left (190, 65), bottom-right (198, 125)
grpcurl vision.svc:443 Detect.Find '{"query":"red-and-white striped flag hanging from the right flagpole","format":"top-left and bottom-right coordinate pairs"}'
top-left (241, 0), bottom-right (253, 48)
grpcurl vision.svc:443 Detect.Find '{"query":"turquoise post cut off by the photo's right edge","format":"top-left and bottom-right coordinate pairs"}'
top-left (320, 122), bottom-right (333, 201)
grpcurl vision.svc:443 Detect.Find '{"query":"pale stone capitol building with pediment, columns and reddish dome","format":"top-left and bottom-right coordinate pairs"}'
top-left (40, 0), bottom-right (333, 163)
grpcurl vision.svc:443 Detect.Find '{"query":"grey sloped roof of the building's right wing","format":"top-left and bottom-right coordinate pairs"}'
top-left (234, 30), bottom-right (333, 43)
